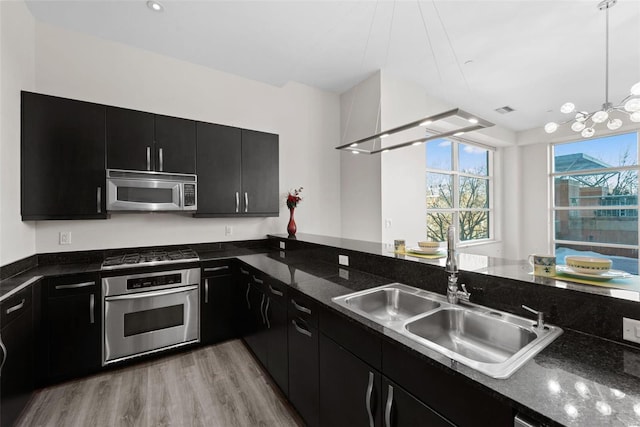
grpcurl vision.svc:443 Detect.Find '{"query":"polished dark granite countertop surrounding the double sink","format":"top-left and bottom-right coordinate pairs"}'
top-left (239, 251), bottom-right (640, 427)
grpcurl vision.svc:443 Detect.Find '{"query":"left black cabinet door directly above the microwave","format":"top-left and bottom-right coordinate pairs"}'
top-left (106, 107), bottom-right (155, 171)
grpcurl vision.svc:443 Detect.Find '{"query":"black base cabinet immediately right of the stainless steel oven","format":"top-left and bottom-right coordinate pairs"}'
top-left (200, 260), bottom-right (236, 344)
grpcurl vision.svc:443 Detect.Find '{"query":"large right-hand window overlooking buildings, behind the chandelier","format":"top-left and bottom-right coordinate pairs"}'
top-left (551, 133), bottom-right (638, 274)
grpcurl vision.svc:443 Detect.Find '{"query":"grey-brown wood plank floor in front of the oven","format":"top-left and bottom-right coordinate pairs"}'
top-left (17, 340), bottom-right (303, 427)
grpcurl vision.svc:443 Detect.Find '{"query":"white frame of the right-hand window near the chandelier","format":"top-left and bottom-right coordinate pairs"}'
top-left (548, 130), bottom-right (640, 271)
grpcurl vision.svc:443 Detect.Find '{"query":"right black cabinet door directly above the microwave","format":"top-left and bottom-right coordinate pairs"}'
top-left (155, 115), bottom-right (196, 173)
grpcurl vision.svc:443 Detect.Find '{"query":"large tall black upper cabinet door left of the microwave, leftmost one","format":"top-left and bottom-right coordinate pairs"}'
top-left (21, 92), bottom-right (106, 220)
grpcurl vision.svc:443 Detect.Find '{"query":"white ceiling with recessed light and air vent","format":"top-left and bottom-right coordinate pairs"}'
top-left (27, 0), bottom-right (640, 131)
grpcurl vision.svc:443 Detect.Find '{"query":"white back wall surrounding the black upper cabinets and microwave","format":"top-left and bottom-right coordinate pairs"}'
top-left (21, 23), bottom-right (340, 253)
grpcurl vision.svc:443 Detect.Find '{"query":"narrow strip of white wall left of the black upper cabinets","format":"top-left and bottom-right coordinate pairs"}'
top-left (0, 1), bottom-right (36, 265)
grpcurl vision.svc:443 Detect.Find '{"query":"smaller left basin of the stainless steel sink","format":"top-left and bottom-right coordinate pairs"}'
top-left (344, 287), bottom-right (440, 322)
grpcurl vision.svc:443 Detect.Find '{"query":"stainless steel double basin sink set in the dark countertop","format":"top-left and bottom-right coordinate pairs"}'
top-left (333, 283), bottom-right (562, 378)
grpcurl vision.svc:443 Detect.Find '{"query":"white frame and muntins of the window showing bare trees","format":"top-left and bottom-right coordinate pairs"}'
top-left (425, 137), bottom-right (497, 247)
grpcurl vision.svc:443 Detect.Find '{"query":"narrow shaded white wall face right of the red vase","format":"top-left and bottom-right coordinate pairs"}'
top-left (336, 72), bottom-right (382, 242)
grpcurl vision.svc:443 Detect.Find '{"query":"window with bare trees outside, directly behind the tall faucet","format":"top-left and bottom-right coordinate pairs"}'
top-left (426, 139), bottom-right (493, 242)
